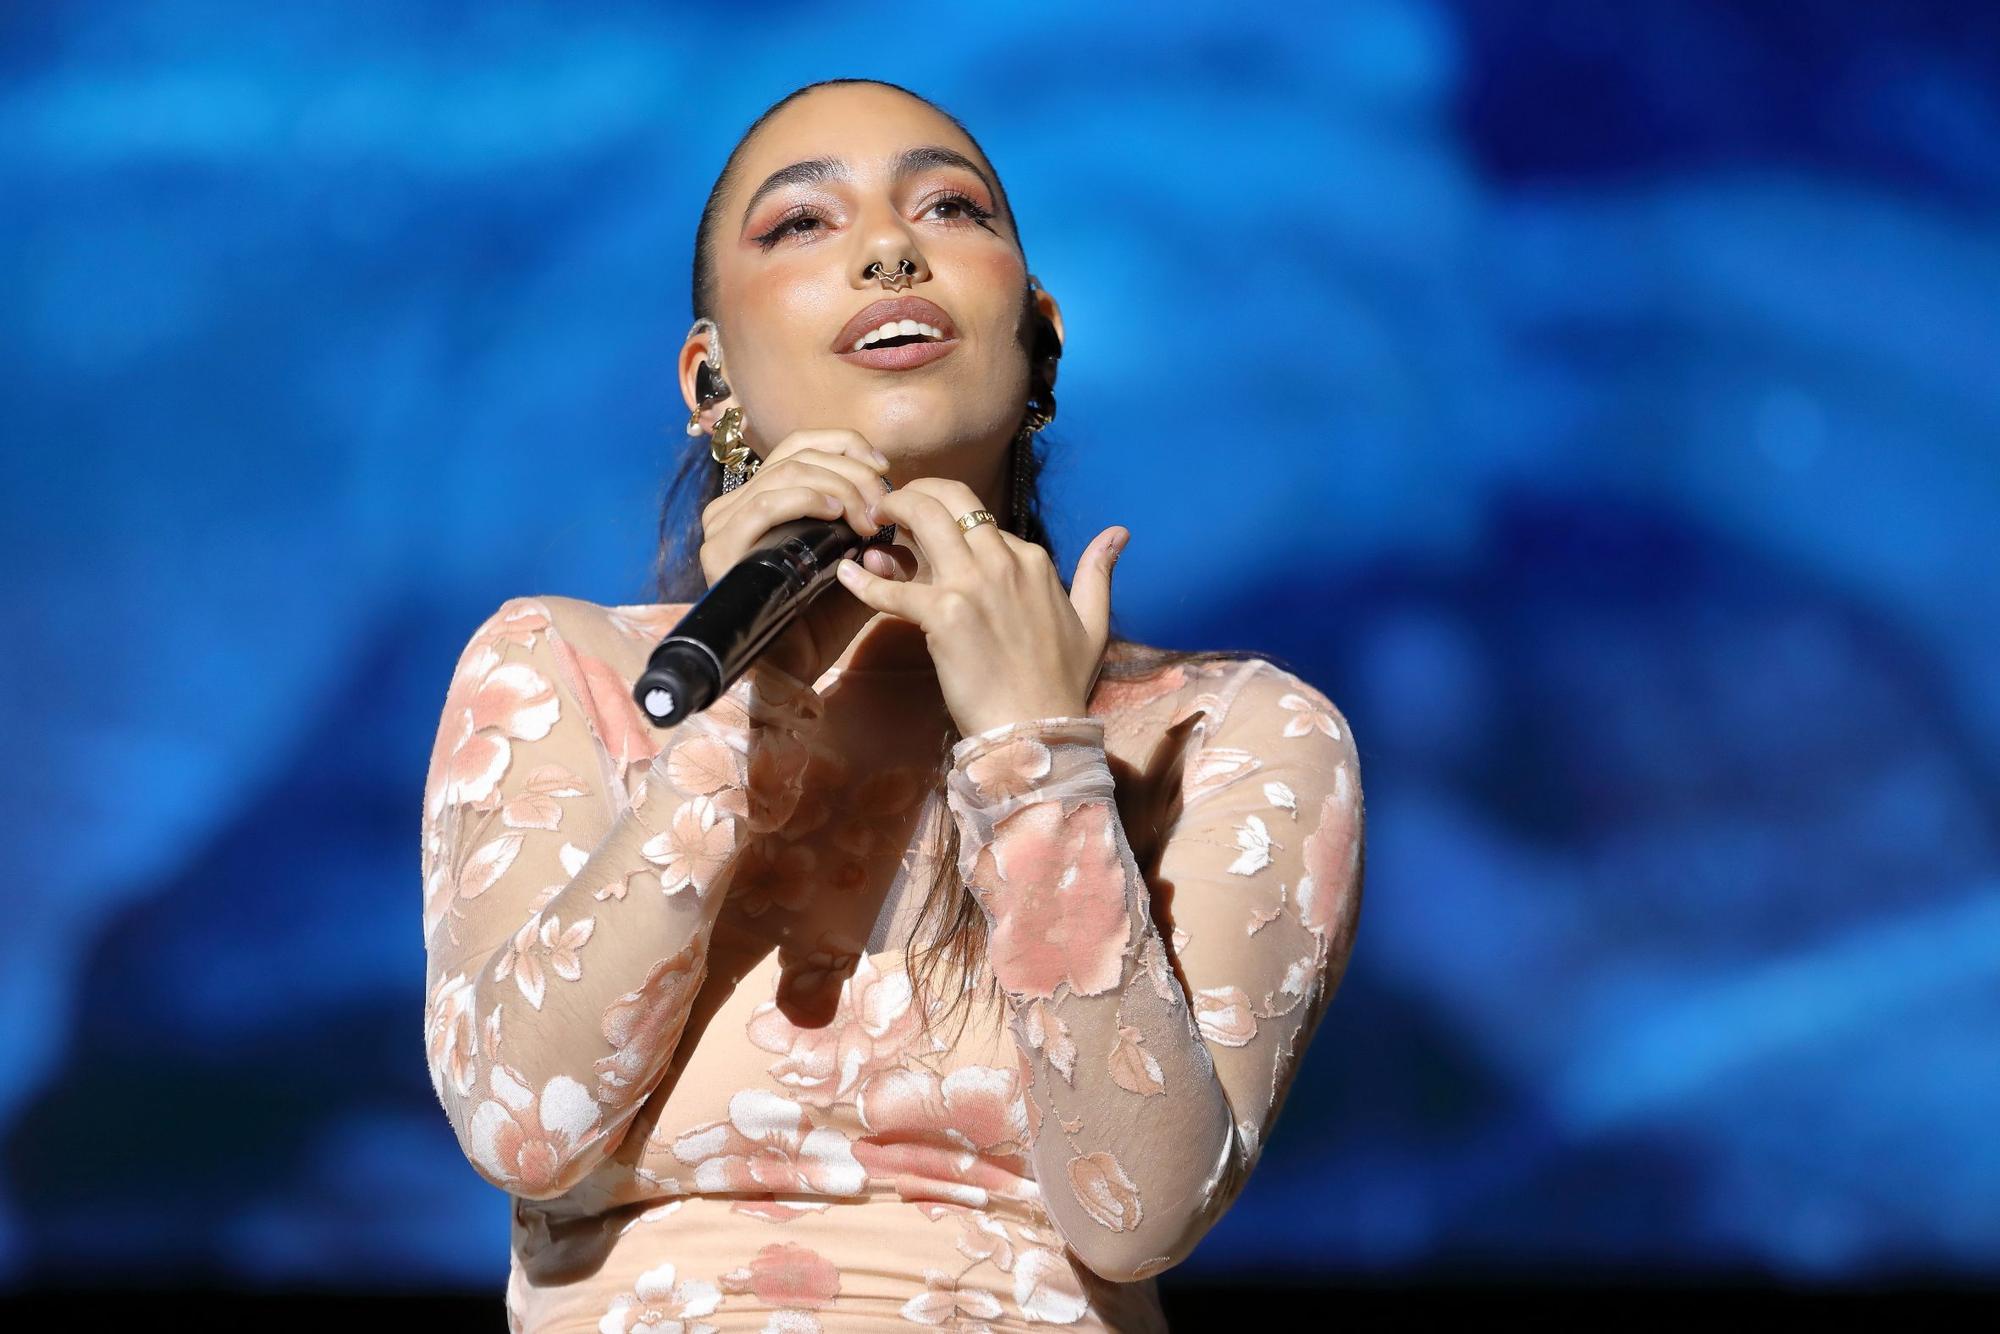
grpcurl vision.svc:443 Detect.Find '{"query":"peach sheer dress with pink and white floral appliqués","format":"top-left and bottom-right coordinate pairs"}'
top-left (422, 596), bottom-right (1364, 1332)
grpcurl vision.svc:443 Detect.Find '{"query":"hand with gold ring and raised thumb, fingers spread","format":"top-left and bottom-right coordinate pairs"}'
top-left (838, 478), bottom-right (1132, 736)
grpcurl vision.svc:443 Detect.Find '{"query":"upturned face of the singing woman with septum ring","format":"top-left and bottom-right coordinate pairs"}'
top-left (714, 84), bottom-right (1060, 486)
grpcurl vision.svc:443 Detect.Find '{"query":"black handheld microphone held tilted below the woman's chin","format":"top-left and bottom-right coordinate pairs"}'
top-left (632, 516), bottom-right (896, 728)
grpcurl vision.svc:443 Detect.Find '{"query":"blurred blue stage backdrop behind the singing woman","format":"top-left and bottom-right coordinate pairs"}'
top-left (0, 0), bottom-right (2000, 1294)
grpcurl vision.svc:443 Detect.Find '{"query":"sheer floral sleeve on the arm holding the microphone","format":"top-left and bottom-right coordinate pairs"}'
top-left (422, 598), bottom-right (820, 1200)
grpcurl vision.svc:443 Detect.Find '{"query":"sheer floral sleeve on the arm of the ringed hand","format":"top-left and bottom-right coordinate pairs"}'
top-left (948, 660), bottom-right (1364, 1282)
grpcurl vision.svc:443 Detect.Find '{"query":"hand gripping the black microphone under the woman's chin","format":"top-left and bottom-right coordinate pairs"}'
top-left (700, 428), bottom-right (914, 686)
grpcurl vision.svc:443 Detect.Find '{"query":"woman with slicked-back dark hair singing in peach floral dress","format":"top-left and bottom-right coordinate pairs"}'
top-left (424, 80), bottom-right (1362, 1330)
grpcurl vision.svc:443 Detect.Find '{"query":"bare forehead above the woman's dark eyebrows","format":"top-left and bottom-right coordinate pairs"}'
top-left (736, 84), bottom-right (992, 185)
